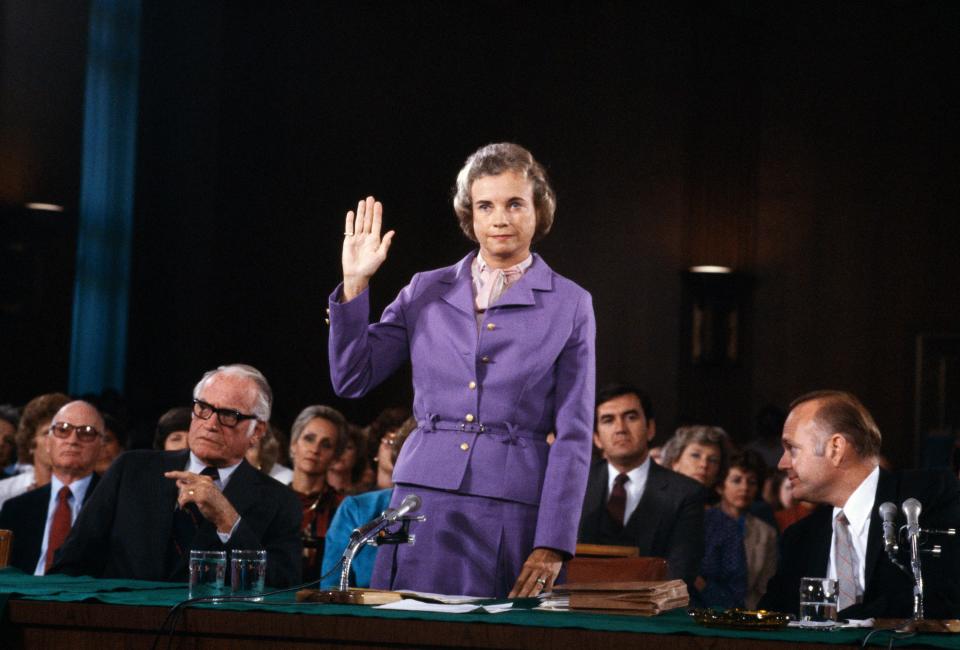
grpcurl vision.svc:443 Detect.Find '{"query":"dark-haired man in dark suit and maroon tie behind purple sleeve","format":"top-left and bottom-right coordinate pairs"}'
top-left (578, 384), bottom-right (704, 588)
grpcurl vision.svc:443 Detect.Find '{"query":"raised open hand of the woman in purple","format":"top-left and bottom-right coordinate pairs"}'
top-left (342, 196), bottom-right (394, 301)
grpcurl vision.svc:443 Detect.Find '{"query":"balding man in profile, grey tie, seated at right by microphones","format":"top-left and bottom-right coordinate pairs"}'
top-left (760, 391), bottom-right (960, 619)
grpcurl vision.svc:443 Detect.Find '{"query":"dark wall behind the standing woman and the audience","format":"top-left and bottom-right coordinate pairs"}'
top-left (0, 0), bottom-right (960, 462)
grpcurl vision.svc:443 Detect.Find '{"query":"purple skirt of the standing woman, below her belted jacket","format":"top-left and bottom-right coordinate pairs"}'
top-left (370, 484), bottom-right (537, 598)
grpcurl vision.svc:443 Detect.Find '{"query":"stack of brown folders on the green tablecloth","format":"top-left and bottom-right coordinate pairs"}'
top-left (544, 580), bottom-right (690, 616)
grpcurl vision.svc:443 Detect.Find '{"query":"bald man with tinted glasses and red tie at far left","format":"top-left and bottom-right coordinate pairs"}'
top-left (0, 401), bottom-right (104, 576)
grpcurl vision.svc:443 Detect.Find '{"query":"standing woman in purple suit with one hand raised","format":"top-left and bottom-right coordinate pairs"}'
top-left (329, 143), bottom-right (595, 597)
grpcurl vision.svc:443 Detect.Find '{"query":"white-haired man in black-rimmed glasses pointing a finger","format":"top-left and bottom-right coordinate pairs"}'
top-left (53, 365), bottom-right (302, 587)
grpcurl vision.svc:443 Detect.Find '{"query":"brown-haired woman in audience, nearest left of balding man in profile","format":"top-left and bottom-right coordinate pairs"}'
top-left (701, 450), bottom-right (777, 609)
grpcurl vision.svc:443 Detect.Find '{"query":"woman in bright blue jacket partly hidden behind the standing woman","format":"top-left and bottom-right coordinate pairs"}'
top-left (321, 418), bottom-right (417, 588)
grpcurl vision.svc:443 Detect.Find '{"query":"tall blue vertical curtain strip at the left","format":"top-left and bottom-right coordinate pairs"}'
top-left (69, 0), bottom-right (141, 395)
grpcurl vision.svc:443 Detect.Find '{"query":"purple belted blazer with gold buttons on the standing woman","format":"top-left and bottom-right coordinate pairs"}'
top-left (329, 252), bottom-right (596, 555)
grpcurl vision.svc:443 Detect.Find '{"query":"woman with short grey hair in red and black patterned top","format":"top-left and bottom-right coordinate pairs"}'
top-left (290, 405), bottom-right (347, 580)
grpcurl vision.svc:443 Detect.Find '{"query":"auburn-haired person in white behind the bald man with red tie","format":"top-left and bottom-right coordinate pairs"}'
top-left (0, 393), bottom-right (70, 505)
